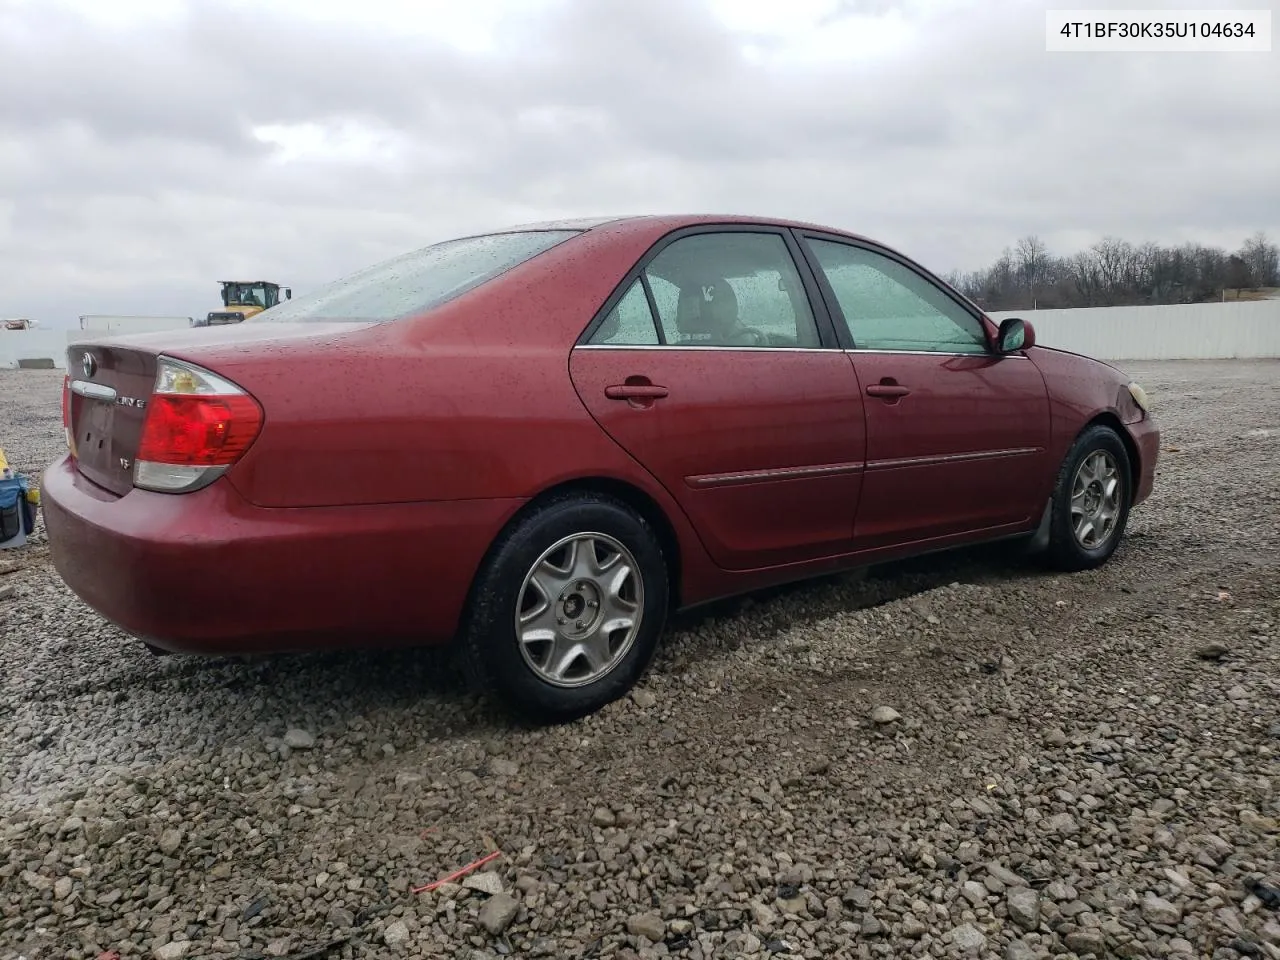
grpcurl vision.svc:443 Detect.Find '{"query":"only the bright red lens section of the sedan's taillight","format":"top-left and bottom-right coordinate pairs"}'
top-left (138, 394), bottom-right (262, 467)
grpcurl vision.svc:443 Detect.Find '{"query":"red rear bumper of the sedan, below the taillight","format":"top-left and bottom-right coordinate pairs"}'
top-left (41, 456), bottom-right (521, 654)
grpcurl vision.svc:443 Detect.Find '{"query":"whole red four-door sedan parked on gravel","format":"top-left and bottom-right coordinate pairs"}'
top-left (42, 216), bottom-right (1160, 719)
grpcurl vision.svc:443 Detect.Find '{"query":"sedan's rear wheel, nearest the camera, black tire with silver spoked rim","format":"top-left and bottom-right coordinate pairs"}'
top-left (462, 493), bottom-right (669, 722)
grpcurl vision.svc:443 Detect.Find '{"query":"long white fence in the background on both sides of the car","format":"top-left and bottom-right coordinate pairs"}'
top-left (0, 300), bottom-right (1280, 369)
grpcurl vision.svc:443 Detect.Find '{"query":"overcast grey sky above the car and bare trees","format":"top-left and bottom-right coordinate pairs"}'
top-left (0, 0), bottom-right (1280, 326)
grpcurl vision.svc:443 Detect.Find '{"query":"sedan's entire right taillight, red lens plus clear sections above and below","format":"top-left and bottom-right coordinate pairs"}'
top-left (133, 357), bottom-right (262, 493)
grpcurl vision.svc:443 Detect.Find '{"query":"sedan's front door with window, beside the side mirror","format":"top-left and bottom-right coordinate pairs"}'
top-left (803, 234), bottom-right (1050, 548)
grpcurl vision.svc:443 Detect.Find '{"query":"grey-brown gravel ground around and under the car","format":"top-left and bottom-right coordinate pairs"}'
top-left (0, 362), bottom-right (1280, 960)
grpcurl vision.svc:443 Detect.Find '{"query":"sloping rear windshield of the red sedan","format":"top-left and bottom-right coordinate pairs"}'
top-left (244, 230), bottom-right (580, 324)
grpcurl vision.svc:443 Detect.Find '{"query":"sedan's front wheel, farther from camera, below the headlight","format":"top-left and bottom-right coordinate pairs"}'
top-left (1047, 424), bottom-right (1133, 571)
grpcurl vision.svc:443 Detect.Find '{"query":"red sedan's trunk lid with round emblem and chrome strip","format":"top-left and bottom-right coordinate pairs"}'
top-left (67, 323), bottom-right (369, 497)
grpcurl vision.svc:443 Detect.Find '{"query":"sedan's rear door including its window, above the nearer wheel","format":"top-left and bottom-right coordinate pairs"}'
top-left (570, 227), bottom-right (865, 570)
